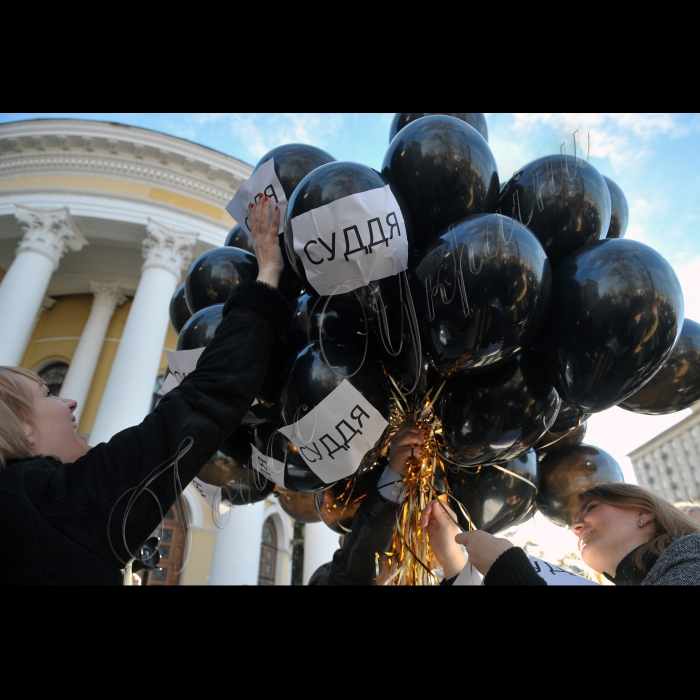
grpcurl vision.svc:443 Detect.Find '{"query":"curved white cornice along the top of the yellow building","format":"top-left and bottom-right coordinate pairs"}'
top-left (0, 119), bottom-right (253, 215)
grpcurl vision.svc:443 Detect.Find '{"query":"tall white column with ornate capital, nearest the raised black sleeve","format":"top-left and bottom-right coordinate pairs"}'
top-left (89, 219), bottom-right (197, 445)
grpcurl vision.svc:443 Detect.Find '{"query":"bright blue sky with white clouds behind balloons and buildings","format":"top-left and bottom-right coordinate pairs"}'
top-left (0, 113), bottom-right (700, 481)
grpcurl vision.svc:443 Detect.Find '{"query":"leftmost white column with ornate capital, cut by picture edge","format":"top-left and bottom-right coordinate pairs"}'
top-left (0, 205), bottom-right (87, 366)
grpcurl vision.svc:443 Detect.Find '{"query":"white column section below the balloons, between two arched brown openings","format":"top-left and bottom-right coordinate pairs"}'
top-left (209, 501), bottom-right (265, 586)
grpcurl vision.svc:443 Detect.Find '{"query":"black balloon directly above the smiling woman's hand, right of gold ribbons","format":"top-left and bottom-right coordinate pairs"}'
top-left (446, 450), bottom-right (540, 535)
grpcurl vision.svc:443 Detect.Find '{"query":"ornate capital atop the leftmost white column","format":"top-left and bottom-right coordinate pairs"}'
top-left (15, 204), bottom-right (88, 271)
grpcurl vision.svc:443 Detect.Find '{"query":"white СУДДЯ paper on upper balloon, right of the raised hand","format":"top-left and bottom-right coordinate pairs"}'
top-left (292, 185), bottom-right (408, 295)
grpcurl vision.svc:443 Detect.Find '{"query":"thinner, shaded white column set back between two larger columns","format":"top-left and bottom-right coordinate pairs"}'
top-left (61, 282), bottom-right (126, 423)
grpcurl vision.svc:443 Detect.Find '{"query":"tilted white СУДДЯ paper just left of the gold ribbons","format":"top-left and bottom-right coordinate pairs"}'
top-left (279, 379), bottom-right (389, 484)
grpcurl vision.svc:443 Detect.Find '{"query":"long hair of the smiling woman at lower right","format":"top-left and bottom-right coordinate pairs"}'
top-left (580, 484), bottom-right (700, 569)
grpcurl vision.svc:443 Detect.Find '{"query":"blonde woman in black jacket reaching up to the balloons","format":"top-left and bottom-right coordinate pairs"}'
top-left (0, 197), bottom-right (291, 585)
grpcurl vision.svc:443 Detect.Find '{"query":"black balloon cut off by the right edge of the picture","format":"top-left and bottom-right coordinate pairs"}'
top-left (618, 318), bottom-right (700, 416)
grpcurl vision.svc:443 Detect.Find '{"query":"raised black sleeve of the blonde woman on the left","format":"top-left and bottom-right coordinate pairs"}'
top-left (31, 282), bottom-right (291, 567)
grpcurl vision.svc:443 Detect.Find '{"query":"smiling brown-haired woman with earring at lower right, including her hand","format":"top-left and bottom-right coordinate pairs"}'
top-left (446, 484), bottom-right (700, 586)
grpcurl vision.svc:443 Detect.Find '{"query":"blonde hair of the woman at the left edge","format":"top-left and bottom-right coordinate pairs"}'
top-left (0, 367), bottom-right (44, 469)
